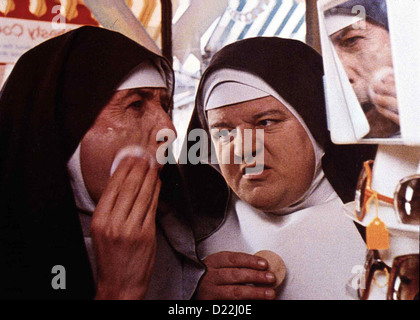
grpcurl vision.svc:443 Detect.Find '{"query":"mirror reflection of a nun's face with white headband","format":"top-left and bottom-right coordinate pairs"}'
top-left (324, 0), bottom-right (400, 138)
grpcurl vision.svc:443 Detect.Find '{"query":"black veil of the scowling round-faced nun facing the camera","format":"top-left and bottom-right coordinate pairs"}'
top-left (181, 37), bottom-right (377, 238)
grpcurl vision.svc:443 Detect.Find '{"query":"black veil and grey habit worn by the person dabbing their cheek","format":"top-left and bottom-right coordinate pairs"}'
top-left (0, 27), bottom-right (204, 299)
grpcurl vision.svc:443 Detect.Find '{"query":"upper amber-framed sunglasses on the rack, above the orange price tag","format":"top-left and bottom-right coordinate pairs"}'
top-left (355, 160), bottom-right (420, 225)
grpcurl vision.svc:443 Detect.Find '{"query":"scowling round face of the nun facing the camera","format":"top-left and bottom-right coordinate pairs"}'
top-left (208, 96), bottom-right (315, 212)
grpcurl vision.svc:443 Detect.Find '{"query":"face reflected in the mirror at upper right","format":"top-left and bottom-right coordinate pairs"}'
top-left (331, 20), bottom-right (399, 137)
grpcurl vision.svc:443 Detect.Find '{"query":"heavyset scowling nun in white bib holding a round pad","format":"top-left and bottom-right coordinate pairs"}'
top-left (182, 37), bottom-right (376, 300)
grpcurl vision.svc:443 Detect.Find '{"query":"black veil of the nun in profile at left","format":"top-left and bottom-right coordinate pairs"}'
top-left (0, 27), bottom-right (173, 299)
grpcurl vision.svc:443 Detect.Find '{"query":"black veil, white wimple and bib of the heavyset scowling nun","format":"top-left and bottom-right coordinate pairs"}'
top-left (181, 38), bottom-right (376, 300)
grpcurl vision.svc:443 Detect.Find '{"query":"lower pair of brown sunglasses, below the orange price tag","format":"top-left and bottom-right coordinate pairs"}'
top-left (358, 250), bottom-right (419, 300)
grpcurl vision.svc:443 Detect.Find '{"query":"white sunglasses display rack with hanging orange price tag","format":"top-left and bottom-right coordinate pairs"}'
top-left (343, 113), bottom-right (420, 300)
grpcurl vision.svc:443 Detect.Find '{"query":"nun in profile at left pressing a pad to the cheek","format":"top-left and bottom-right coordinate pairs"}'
top-left (0, 27), bottom-right (204, 300)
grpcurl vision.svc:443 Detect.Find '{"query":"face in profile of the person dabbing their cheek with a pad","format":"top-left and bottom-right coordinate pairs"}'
top-left (80, 88), bottom-right (175, 203)
